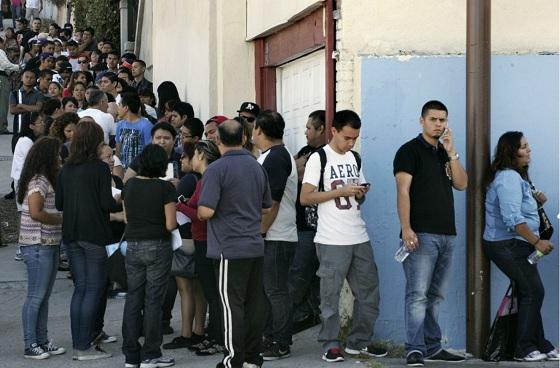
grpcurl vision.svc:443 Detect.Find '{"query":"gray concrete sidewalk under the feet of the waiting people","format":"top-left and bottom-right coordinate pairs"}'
top-left (0, 242), bottom-right (558, 368)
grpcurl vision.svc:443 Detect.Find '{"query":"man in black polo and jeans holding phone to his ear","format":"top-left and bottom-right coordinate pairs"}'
top-left (393, 101), bottom-right (467, 367)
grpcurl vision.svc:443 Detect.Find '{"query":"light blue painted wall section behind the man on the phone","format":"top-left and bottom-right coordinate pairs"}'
top-left (361, 55), bottom-right (560, 348)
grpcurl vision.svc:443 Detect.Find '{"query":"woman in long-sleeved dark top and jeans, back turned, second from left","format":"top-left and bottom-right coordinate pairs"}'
top-left (55, 120), bottom-right (115, 360)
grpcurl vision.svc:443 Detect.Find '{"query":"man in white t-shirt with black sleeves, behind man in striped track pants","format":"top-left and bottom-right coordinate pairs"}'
top-left (253, 110), bottom-right (298, 361)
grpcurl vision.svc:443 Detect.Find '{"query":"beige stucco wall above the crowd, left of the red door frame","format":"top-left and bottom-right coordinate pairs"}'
top-left (148, 0), bottom-right (255, 121)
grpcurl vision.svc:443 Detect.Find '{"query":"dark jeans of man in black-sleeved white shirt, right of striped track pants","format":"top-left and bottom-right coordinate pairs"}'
top-left (263, 240), bottom-right (297, 345)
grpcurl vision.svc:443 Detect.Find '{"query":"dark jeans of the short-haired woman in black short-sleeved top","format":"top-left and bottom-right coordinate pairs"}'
top-left (122, 239), bottom-right (173, 364)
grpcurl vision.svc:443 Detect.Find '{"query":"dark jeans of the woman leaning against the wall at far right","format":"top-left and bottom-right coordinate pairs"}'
top-left (483, 238), bottom-right (554, 358)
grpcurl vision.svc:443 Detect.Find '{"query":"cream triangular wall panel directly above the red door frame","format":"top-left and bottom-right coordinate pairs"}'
top-left (247, 0), bottom-right (324, 40)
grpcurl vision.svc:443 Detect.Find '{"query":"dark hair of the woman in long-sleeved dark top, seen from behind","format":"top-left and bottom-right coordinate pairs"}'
top-left (66, 119), bottom-right (103, 165)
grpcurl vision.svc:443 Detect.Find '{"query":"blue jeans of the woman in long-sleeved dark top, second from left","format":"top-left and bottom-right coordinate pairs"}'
top-left (66, 241), bottom-right (107, 350)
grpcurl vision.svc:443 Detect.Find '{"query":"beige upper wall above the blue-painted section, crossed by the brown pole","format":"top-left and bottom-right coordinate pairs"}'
top-left (336, 0), bottom-right (560, 112)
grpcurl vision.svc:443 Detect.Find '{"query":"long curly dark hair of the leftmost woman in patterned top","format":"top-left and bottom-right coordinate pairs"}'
top-left (17, 137), bottom-right (60, 203)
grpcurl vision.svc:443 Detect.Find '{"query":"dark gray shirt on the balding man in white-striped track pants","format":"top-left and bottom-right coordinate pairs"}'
top-left (198, 149), bottom-right (272, 259)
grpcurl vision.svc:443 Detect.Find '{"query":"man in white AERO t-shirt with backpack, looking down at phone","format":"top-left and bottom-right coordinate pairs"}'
top-left (300, 110), bottom-right (387, 362)
